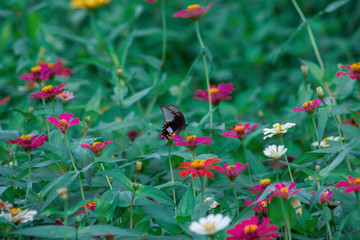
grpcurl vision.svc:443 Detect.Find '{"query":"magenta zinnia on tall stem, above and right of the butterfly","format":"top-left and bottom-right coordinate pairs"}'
top-left (193, 83), bottom-right (235, 106)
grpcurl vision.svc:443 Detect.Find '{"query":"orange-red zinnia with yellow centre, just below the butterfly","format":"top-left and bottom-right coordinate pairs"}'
top-left (178, 158), bottom-right (220, 178)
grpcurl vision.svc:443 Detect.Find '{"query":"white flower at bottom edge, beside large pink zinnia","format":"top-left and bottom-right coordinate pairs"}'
top-left (189, 213), bottom-right (231, 236)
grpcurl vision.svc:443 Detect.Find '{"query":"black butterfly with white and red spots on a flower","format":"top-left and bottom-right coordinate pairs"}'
top-left (160, 104), bottom-right (187, 139)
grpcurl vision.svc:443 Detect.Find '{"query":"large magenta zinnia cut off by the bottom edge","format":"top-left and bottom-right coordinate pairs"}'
top-left (226, 216), bottom-right (280, 240)
